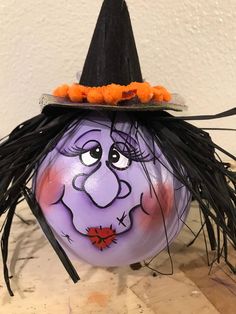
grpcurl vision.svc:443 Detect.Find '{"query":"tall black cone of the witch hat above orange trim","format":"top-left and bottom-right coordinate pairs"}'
top-left (80, 0), bottom-right (143, 86)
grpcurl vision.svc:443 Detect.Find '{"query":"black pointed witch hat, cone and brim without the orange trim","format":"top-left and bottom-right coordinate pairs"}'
top-left (40, 0), bottom-right (185, 111)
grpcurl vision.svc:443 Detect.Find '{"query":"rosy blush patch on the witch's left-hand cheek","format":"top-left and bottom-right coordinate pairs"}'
top-left (36, 167), bottom-right (63, 211)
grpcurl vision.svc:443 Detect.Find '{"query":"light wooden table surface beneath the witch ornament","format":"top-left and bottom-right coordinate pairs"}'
top-left (0, 204), bottom-right (236, 314)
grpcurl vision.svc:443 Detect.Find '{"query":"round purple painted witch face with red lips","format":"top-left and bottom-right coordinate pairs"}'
top-left (35, 114), bottom-right (190, 266)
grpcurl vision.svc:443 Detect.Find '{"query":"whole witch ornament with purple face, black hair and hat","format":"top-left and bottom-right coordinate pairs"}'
top-left (0, 0), bottom-right (236, 295)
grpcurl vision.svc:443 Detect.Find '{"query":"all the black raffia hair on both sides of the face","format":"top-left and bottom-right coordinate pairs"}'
top-left (0, 108), bottom-right (236, 296)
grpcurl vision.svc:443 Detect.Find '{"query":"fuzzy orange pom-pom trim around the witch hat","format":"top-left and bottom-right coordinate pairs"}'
top-left (53, 82), bottom-right (171, 106)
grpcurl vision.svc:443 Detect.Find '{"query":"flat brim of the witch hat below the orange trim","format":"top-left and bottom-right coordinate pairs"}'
top-left (40, 94), bottom-right (188, 112)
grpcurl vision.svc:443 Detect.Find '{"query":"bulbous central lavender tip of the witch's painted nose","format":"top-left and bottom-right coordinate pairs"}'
top-left (84, 165), bottom-right (121, 208)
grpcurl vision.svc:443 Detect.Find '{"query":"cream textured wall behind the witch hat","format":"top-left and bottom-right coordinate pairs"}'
top-left (0, 0), bottom-right (236, 154)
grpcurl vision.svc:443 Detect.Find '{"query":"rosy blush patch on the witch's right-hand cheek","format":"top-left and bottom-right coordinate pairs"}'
top-left (137, 184), bottom-right (173, 230)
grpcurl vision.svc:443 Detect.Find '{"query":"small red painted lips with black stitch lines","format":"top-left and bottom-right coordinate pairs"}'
top-left (86, 226), bottom-right (117, 251)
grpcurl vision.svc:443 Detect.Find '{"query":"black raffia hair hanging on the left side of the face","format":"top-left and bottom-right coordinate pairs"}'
top-left (0, 112), bottom-right (84, 296)
